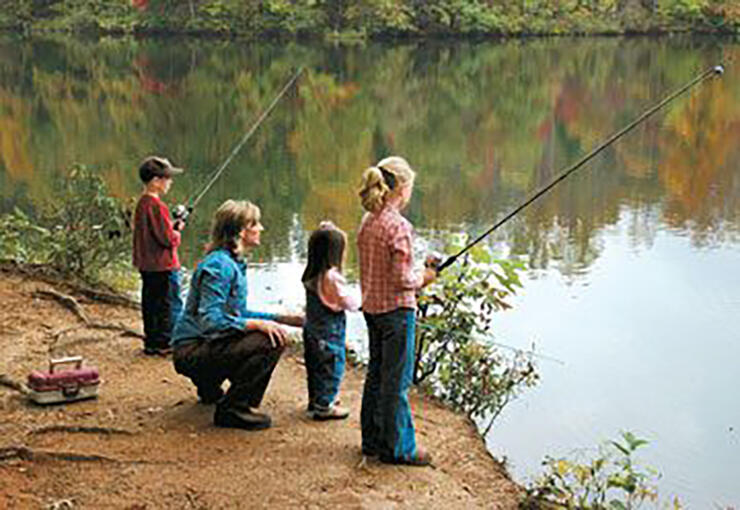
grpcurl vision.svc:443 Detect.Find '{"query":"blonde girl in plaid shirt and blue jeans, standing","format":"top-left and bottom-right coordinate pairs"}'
top-left (357, 156), bottom-right (436, 466)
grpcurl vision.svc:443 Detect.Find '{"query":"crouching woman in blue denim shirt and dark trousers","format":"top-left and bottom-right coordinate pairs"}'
top-left (172, 200), bottom-right (303, 429)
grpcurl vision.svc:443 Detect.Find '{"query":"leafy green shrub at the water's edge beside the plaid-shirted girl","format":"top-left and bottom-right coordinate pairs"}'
top-left (415, 238), bottom-right (539, 435)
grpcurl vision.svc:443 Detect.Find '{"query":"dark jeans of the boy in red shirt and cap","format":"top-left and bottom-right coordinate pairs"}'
top-left (140, 271), bottom-right (182, 349)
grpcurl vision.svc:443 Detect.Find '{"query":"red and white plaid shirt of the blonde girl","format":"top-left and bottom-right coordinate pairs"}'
top-left (357, 206), bottom-right (423, 314)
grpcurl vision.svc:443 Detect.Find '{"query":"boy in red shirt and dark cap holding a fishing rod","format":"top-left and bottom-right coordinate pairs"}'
top-left (133, 156), bottom-right (185, 355)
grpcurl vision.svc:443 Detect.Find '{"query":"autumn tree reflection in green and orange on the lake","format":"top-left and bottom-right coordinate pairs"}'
top-left (0, 35), bottom-right (740, 266)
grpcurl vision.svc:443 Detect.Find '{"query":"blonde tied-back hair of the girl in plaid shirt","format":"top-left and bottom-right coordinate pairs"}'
top-left (359, 156), bottom-right (416, 212)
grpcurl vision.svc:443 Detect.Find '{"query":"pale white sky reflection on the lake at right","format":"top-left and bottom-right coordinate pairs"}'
top-left (488, 225), bottom-right (740, 508)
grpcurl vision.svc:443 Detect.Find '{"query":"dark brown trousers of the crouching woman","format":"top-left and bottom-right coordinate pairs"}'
top-left (173, 331), bottom-right (284, 410)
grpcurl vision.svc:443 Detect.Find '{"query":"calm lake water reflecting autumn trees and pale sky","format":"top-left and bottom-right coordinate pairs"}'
top-left (0, 37), bottom-right (740, 508)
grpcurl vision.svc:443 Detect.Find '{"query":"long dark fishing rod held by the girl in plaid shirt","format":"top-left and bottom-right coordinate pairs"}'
top-left (436, 65), bottom-right (725, 274)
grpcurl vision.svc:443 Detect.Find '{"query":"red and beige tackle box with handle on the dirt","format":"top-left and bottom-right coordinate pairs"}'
top-left (28, 356), bottom-right (100, 404)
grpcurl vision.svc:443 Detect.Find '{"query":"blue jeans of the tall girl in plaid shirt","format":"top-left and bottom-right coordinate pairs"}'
top-left (360, 308), bottom-right (416, 459)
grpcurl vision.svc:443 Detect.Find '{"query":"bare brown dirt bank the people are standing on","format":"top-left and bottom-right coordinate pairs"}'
top-left (0, 272), bottom-right (516, 510)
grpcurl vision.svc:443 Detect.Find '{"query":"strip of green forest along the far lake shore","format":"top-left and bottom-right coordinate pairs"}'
top-left (0, 0), bottom-right (740, 38)
